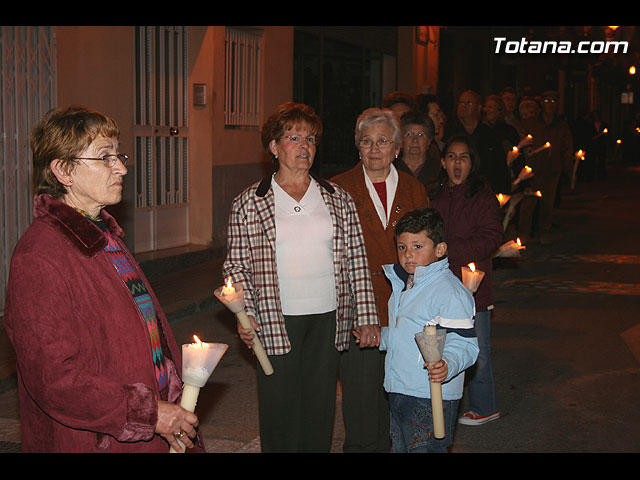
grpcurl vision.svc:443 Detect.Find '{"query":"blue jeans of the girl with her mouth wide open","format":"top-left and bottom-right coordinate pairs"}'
top-left (466, 310), bottom-right (498, 415)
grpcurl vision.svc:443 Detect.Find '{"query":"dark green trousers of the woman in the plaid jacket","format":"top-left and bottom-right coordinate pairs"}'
top-left (258, 311), bottom-right (339, 453)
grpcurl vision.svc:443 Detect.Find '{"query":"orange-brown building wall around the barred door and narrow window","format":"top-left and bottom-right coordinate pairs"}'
top-left (57, 26), bottom-right (293, 253)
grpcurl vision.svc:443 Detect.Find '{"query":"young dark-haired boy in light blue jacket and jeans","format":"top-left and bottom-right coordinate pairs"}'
top-left (380, 208), bottom-right (478, 453)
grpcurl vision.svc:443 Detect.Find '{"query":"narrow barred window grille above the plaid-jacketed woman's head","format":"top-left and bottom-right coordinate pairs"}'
top-left (224, 27), bottom-right (262, 126)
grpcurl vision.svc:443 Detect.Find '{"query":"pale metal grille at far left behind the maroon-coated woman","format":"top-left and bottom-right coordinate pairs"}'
top-left (0, 26), bottom-right (56, 314)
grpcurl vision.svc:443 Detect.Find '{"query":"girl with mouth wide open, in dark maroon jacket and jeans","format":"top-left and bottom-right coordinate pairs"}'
top-left (431, 135), bottom-right (504, 425)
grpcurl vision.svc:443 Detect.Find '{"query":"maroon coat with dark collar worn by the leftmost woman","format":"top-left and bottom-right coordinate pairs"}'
top-left (5, 195), bottom-right (188, 453)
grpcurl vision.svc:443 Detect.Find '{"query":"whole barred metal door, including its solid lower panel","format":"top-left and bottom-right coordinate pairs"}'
top-left (133, 26), bottom-right (189, 252)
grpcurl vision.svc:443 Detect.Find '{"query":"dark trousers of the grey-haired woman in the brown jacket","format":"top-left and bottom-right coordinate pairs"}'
top-left (340, 336), bottom-right (391, 453)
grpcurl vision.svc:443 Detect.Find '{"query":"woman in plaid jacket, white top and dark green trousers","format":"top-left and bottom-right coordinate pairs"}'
top-left (223, 102), bottom-right (380, 452)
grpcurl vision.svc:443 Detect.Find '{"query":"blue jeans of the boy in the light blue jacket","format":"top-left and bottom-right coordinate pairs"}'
top-left (389, 393), bottom-right (459, 453)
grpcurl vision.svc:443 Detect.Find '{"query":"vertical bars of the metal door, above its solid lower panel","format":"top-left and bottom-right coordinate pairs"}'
top-left (134, 26), bottom-right (189, 207)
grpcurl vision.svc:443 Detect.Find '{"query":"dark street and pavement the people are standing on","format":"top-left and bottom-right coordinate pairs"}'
top-left (0, 165), bottom-right (640, 453)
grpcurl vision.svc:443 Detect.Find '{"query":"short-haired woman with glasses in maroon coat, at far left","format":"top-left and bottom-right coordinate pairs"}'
top-left (5, 107), bottom-right (201, 453)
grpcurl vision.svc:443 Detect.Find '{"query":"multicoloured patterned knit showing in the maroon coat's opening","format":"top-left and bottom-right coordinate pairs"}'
top-left (80, 211), bottom-right (169, 400)
